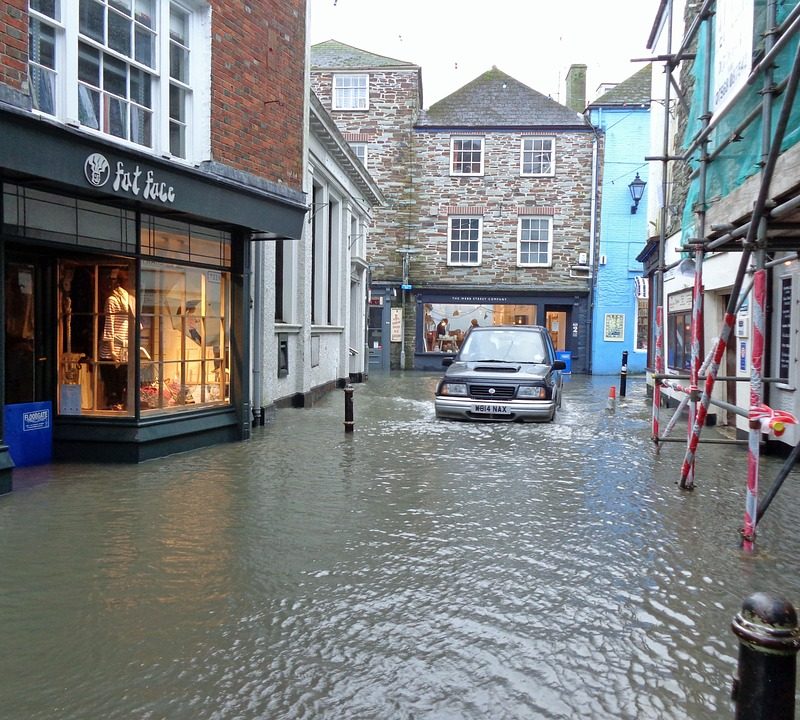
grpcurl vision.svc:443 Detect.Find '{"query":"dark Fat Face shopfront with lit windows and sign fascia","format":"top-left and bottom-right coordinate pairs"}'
top-left (0, 112), bottom-right (305, 484)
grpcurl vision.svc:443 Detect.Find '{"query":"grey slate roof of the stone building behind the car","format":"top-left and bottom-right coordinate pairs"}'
top-left (415, 67), bottom-right (587, 129)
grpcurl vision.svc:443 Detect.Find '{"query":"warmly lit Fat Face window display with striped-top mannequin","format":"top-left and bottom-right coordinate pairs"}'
top-left (59, 260), bottom-right (229, 415)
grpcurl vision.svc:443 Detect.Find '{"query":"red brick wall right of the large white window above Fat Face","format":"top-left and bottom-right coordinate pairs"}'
top-left (211, 0), bottom-right (306, 189)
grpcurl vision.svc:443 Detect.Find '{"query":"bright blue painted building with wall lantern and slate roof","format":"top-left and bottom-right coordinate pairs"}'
top-left (587, 65), bottom-right (652, 375)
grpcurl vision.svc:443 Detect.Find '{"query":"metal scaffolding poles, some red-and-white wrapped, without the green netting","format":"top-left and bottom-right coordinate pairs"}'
top-left (647, 0), bottom-right (800, 550)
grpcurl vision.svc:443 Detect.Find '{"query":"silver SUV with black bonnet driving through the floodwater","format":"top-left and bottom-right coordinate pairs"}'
top-left (435, 325), bottom-right (566, 422)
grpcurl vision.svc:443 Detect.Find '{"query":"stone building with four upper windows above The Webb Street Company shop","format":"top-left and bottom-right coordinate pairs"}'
top-left (408, 68), bottom-right (598, 371)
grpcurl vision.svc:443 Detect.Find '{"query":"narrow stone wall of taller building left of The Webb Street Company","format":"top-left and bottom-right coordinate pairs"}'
top-left (311, 68), bottom-right (420, 281)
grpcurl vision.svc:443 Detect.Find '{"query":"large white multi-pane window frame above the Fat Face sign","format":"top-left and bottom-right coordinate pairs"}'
top-left (28, 0), bottom-right (206, 164)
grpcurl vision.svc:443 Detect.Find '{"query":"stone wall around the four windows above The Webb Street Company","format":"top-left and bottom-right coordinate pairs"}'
top-left (412, 131), bottom-right (593, 290)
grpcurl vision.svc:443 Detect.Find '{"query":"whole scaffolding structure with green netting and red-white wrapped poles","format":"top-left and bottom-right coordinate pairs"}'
top-left (647, 0), bottom-right (800, 550)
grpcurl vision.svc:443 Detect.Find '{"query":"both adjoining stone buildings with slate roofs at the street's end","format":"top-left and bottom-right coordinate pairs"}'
top-left (311, 41), bottom-right (601, 371)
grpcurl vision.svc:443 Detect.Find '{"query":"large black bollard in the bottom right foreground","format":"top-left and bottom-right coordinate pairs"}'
top-left (731, 593), bottom-right (800, 720)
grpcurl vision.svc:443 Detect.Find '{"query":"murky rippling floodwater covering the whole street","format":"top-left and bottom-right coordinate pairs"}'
top-left (0, 373), bottom-right (800, 720)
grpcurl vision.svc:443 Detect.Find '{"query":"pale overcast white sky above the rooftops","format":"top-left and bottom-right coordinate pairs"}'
top-left (309, 0), bottom-right (659, 108)
